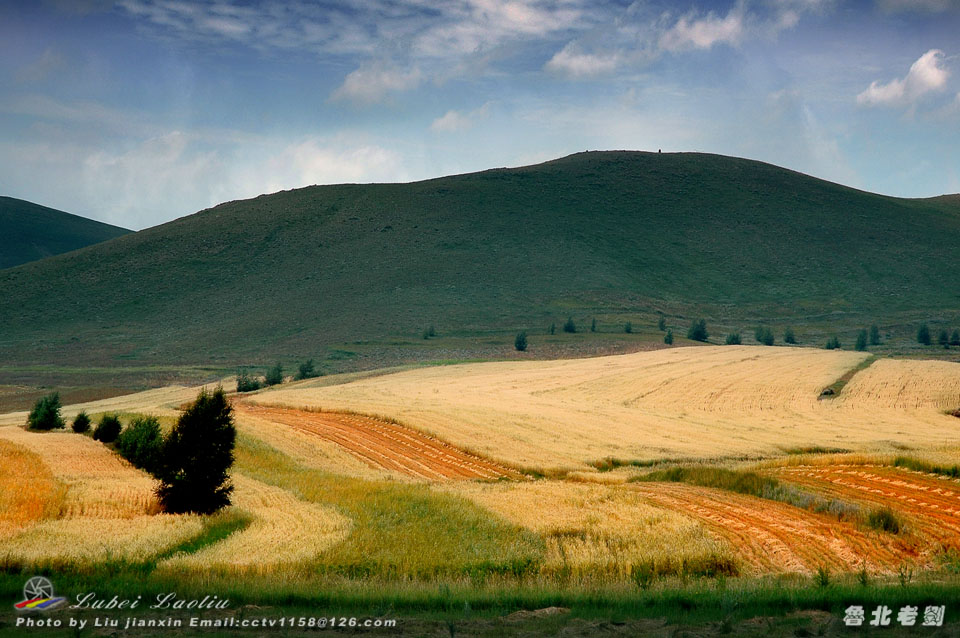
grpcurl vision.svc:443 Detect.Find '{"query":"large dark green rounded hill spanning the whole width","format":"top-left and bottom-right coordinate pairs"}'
top-left (0, 152), bottom-right (960, 363)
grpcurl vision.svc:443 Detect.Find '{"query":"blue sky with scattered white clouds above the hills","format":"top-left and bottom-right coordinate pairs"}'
top-left (0, 0), bottom-right (960, 230)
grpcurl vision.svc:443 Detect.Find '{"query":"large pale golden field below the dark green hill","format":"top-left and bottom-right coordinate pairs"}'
top-left (249, 346), bottom-right (960, 470)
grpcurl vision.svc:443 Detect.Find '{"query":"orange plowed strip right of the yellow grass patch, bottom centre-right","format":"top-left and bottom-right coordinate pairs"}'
top-left (634, 483), bottom-right (917, 573)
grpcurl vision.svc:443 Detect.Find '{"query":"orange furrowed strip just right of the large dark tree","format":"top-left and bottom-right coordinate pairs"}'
top-left (234, 401), bottom-right (521, 479)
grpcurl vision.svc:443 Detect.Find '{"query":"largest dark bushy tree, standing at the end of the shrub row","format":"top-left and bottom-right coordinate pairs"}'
top-left (157, 388), bottom-right (237, 514)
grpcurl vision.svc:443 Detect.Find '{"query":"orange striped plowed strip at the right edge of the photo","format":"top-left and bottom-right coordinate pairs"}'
top-left (777, 465), bottom-right (960, 549)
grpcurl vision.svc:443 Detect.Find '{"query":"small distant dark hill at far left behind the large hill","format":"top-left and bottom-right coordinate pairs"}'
top-left (0, 197), bottom-right (130, 269)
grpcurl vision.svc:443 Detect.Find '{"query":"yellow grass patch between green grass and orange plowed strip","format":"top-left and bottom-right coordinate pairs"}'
top-left (435, 481), bottom-right (732, 577)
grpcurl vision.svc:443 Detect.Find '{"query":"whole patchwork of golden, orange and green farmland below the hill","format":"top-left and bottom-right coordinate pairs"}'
top-left (0, 346), bottom-right (960, 632)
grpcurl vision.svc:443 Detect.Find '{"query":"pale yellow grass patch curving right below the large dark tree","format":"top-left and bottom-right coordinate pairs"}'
top-left (160, 474), bottom-right (350, 571)
